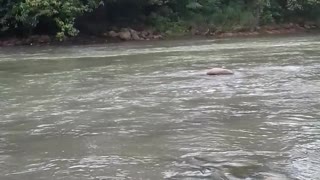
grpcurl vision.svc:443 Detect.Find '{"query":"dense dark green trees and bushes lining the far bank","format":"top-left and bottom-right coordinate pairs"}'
top-left (0, 0), bottom-right (320, 39)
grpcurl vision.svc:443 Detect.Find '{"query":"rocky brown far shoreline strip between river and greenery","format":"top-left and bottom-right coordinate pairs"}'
top-left (0, 23), bottom-right (320, 47)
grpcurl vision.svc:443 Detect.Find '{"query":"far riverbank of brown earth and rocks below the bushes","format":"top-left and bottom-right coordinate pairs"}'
top-left (0, 23), bottom-right (320, 47)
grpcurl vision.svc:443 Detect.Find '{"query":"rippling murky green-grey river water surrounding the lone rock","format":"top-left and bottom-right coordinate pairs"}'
top-left (0, 35), bottom-right (320, 180)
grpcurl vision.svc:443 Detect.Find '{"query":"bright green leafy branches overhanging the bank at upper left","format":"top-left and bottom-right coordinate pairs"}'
top-left (0, 0), bottom-right (97, 38)
